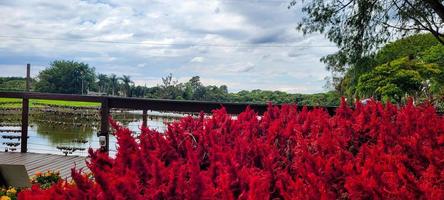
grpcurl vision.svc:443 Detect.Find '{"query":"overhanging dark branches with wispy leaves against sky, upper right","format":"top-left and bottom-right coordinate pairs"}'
top-left (289, 0), bottom-right (444, 76)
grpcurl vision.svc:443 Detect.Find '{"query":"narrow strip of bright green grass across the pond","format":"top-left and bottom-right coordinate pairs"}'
top-left (0, 98), bottom-right (100, 108)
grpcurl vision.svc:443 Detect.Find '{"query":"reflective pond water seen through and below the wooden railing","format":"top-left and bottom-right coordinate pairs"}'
top-left (0, 110), bottom-right (183, 156)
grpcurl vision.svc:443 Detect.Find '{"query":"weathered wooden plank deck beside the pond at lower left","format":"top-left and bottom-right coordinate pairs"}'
top-left (0, 152), bottom-right (87, 178)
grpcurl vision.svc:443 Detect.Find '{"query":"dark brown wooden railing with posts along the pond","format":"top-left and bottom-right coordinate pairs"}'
top-left (0, 92), bottom-right (336, 153)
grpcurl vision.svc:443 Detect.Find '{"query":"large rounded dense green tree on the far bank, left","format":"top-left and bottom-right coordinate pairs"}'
top-left (35, 60), bottom-right (96, 94)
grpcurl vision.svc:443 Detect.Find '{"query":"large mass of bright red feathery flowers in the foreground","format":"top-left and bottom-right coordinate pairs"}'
top-left (19, 99), bottom-right (444, 199)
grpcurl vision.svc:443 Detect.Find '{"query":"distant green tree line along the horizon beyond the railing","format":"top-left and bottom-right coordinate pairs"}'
top-left (0, 60), bottom-right (340, 106)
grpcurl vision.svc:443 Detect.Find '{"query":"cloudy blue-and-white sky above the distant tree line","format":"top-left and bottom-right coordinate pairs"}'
top-left (0, 0), bottom-right (336, 93)
